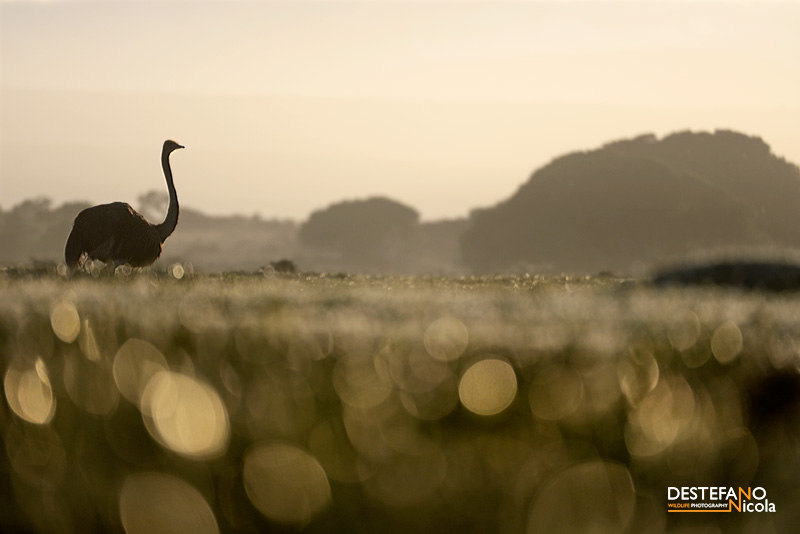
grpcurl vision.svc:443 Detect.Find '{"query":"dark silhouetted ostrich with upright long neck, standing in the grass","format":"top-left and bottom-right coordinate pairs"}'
top-left (64, 140), bottom-right (183, 269)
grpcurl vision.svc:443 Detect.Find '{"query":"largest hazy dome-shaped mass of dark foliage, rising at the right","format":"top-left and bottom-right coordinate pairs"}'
top-left (461, 131), bottom-right (800, 273)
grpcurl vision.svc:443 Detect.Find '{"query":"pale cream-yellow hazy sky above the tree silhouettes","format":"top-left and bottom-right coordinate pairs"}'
top-left (0, 0), bottom-right (800, 220)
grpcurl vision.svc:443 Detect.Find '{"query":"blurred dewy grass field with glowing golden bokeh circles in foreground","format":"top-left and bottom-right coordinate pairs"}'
top-left (0, 268), bottom-right (800, 534)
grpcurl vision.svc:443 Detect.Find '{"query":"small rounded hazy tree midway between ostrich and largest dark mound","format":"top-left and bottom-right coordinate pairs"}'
top-left (300, 197), bottom-right (419, 272)
